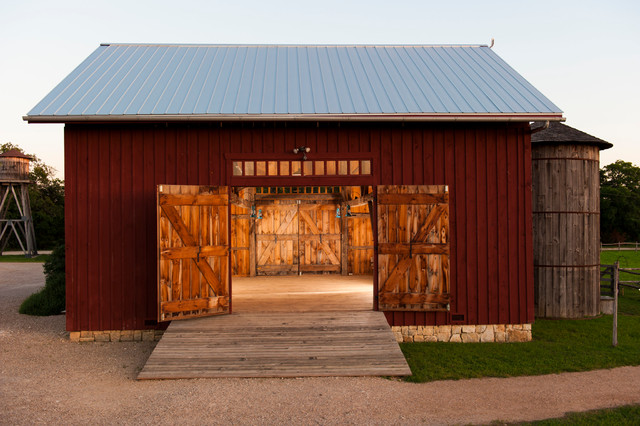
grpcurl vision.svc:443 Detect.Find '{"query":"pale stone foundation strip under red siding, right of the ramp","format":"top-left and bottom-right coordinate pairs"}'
top-left (391, 324), bottom-right (531, 343)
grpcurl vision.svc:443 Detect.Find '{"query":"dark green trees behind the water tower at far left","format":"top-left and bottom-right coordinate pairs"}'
top-left (0, 142), bottom-right (64, 250)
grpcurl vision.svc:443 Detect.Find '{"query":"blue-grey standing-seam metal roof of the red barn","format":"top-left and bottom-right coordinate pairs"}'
top-left (24, 44), bottom-right (562, 122)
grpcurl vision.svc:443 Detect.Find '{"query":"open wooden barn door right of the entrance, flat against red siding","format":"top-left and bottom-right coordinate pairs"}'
top-left (377, 185), bottom-right (450, 311)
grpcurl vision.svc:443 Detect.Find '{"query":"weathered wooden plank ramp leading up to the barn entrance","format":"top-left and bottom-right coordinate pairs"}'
top-left (138, 311), bottom-right (411, 379)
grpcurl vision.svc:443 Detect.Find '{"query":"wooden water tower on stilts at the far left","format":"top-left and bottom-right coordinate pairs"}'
top-left (0, 149), bottom-right (38, 257)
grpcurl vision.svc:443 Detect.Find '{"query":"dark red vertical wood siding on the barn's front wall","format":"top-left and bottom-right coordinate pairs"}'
top-left (65, 123), bottom-right (533, 331)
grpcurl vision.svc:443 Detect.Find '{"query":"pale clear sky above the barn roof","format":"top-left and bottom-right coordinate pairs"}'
top-left (0, 0), bottom-right (640, 178)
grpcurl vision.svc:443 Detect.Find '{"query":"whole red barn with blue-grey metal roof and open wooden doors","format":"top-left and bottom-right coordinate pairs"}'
top-left (25, 45), bottom-right (562, 341)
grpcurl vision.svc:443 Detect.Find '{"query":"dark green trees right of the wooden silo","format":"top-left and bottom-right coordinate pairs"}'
top-left (600, 160), bottom-right (640, 243)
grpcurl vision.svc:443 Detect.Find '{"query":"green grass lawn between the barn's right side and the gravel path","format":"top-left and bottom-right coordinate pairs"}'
top-left (400, 251), bottom-right (640, 382)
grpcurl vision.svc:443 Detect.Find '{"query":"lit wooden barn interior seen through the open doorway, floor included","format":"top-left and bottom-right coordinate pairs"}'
top-left (230, 186), bottom-right (374, 312)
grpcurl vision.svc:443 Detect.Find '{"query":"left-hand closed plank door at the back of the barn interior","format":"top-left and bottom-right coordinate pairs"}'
top-left (255, 202), bottom-right (299, 275)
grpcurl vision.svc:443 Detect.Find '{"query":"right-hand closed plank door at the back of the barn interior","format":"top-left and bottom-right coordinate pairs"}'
top-left (299, 204), bottom-right (342, 273)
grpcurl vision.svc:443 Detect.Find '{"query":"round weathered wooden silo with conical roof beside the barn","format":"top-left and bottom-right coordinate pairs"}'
top-left (531, 122), bottom-right (613, 318)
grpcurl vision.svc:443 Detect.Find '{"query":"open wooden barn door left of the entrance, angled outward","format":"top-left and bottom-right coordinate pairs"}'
top-left (158, 185), bottom-right (230, 321)
